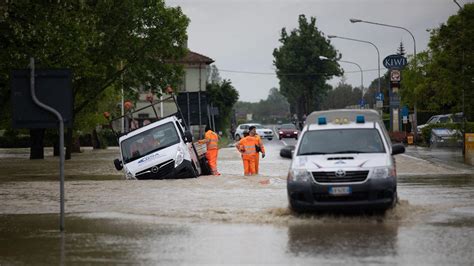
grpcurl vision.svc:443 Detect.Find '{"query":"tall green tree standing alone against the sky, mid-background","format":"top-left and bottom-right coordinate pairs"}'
top-left (273, 15), bottom-right (342, 116)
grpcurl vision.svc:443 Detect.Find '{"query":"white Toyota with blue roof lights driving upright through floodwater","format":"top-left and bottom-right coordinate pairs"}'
top-left (287, 109), bottom-right (405, 212)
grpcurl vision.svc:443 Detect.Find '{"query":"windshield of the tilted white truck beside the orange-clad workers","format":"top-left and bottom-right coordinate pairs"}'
top-left (121, 122), bottom-right (179, 163)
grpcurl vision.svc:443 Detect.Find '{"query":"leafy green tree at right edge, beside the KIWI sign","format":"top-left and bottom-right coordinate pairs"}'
top-left (402, 3), bottom-right (474, 120)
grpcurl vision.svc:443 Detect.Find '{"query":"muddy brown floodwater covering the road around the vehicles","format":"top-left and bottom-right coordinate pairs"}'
top-left (0, 139), bottom-right (474, 265)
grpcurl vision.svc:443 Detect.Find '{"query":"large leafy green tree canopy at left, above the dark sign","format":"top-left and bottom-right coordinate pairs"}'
top-left (0, 0), bottom-right (189, 157)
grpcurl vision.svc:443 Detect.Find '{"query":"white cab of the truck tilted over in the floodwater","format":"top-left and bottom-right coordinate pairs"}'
top-left (114, 115), bottom-right (201, 179)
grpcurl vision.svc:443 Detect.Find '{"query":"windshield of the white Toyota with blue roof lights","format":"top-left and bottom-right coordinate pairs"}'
top-left (298, 128), bottom-right (385, 155)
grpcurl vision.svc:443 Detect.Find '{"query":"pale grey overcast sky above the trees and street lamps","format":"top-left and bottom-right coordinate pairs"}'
top-left (166, 0), bottom-right (473, 102)
